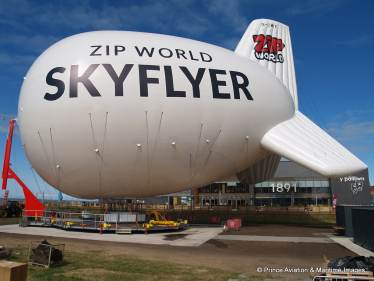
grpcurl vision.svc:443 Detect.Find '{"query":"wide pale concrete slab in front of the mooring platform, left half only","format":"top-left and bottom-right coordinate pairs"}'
top-left (0, 225), bottom-right (222, 247)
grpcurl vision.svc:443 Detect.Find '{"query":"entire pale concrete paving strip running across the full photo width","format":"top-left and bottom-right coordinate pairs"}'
top-left (0, 225), bottom-right (374, 256)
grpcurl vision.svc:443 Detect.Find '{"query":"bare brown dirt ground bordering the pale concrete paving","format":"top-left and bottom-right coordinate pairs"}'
top-left (0, 225), bottom-right (356, 280)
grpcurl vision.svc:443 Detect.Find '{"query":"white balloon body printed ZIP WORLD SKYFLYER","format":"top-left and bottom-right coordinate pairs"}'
top-left (18, 18), bottom-right (366, 199)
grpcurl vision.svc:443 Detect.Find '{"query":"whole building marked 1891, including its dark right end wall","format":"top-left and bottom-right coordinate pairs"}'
top-left (191, 161), bottom-right (371, 208)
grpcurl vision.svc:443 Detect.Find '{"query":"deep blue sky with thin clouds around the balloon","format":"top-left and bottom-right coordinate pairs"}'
top-left (0, 0), bottom-right (374, 199)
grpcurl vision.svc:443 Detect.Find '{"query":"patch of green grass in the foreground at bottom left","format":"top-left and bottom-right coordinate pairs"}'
top-left (12, 248), bottom-right (243, 281)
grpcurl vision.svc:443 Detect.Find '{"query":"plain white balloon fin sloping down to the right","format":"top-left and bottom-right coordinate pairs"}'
top-left (261, 110), bottom-right (367, 178)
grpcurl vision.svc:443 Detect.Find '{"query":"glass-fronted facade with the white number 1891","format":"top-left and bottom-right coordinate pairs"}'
top-left (196, 178), bottom-right (331, 206)
